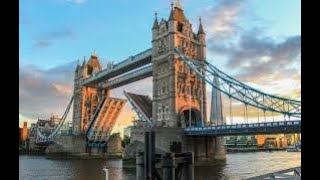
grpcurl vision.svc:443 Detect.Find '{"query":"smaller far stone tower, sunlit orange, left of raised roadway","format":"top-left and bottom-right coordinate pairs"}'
top-left (72, 53), bottom-right (101, 135)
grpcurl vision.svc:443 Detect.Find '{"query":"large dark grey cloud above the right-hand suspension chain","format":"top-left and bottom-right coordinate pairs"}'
top-left (209, 33), bottom-right (301, 83)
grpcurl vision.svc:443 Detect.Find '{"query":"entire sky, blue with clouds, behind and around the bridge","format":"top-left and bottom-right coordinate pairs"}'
top-left (19, 0), bottom-right (301, 135)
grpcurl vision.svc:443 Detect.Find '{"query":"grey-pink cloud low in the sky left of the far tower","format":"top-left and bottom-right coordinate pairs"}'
top-left (19, 62), bottom-right (76, 120)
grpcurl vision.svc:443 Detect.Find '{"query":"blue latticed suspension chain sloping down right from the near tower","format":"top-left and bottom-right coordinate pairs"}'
top-left (175, 49), bottom-right (301, 118)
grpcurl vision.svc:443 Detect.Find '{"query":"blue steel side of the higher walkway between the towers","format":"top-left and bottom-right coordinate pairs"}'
top-left (83, 48), bottom-right (152, 85)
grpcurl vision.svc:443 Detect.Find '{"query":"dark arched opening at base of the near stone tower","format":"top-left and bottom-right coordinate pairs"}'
top-left (178, 109), bottom-right (202, 127)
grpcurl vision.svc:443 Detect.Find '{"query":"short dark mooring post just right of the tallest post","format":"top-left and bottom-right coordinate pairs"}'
top-left (161, 153), bottom-right (175, 180)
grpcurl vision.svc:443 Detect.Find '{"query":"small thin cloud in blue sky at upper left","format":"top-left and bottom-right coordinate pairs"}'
top-left (33, 28), bottom-right (76, 48)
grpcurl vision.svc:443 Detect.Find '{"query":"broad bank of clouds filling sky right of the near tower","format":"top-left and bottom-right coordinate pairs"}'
top-left (203, 0), bottom-right (301, 100)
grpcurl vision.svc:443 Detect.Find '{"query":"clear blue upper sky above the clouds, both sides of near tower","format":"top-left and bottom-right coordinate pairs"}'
top-left (19, 0), bottom-right (301, 69)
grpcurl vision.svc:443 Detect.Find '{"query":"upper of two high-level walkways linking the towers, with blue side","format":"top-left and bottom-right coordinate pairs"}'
top-left (83, 48), bottom-right (152, 86)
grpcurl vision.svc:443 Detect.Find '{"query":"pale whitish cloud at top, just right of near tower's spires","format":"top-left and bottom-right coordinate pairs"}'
top-left (203, 0), bottom-right (245, 40)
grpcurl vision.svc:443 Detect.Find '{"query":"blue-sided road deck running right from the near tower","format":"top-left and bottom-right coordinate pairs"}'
top-left (184, 120), bottom-right (301, 136)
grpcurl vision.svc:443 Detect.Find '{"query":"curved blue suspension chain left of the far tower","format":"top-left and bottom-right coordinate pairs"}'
top-left (36, 96), bottom-right (73, 143)
